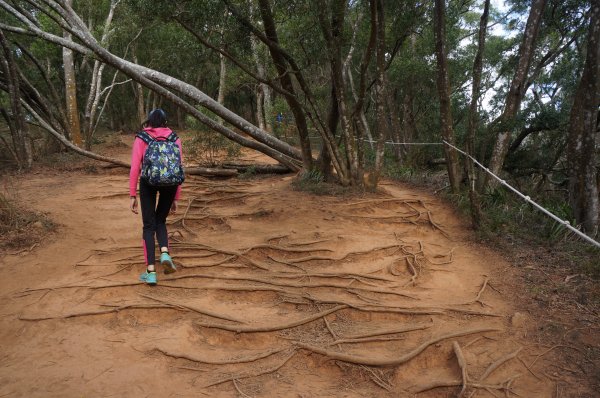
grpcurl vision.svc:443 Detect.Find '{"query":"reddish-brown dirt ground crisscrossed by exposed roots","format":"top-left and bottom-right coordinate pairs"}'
top-left (0, 131), bottom-right (600, 398)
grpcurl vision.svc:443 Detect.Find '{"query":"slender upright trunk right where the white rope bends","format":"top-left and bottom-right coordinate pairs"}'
top-left (434, 0), bottom-right (460, 193)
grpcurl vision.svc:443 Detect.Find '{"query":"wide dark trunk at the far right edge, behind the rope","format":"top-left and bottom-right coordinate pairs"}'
top-left (567, 0), bottom-right (600, 235)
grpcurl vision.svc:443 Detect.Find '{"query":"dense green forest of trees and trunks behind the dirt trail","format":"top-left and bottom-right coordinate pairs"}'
top-left (0, 0), bottom-right (600, 235)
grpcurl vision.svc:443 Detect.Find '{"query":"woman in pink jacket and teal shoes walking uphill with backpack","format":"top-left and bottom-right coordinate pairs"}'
top-left (129, 109), bottom-right (184, 285)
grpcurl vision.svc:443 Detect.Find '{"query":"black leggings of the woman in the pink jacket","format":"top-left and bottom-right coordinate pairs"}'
top-left (140, 179), bottom-right (177, 265)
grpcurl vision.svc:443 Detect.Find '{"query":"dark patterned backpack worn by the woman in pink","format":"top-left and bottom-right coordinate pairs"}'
top-left (136, 131), bottom-right (185, 186)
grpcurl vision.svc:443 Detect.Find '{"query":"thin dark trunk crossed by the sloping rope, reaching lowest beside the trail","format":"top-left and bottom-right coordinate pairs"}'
top-left (465, 0), bottom-right (490, 229)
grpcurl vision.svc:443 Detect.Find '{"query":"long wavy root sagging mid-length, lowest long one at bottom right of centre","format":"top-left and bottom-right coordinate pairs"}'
top-left (297, 328), bottom-right (499, 366)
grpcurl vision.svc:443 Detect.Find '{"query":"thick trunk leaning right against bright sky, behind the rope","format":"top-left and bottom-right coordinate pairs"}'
top-left (483, 0), bottom-right (546, 187)
